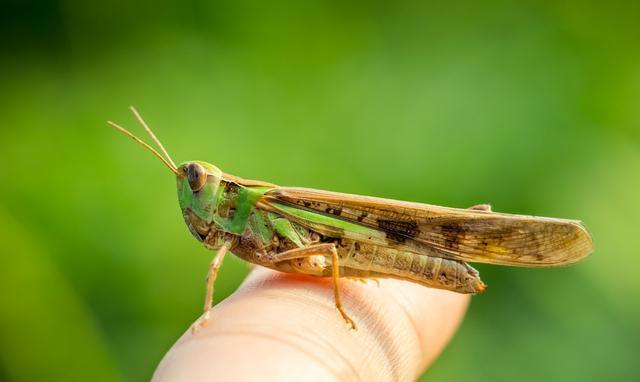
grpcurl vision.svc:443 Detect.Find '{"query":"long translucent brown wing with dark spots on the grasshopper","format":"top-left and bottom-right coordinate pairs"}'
top-left (265, 187), bottom-right (593, 267)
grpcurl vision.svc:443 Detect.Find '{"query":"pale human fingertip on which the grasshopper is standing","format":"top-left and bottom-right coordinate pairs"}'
top-left (153, 267), bottom-right (469, 382)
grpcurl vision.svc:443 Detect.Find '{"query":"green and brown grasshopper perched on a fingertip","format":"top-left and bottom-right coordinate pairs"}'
top-left (108, 106), bottom-right (593, 329)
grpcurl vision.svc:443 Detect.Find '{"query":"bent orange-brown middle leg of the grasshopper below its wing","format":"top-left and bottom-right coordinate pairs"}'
top-left (269, 243), bottom-right (357, 330)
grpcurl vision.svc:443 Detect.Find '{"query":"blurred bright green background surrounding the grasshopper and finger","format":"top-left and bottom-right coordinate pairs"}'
top-left (0, 0), bottom-right (640, 381)
